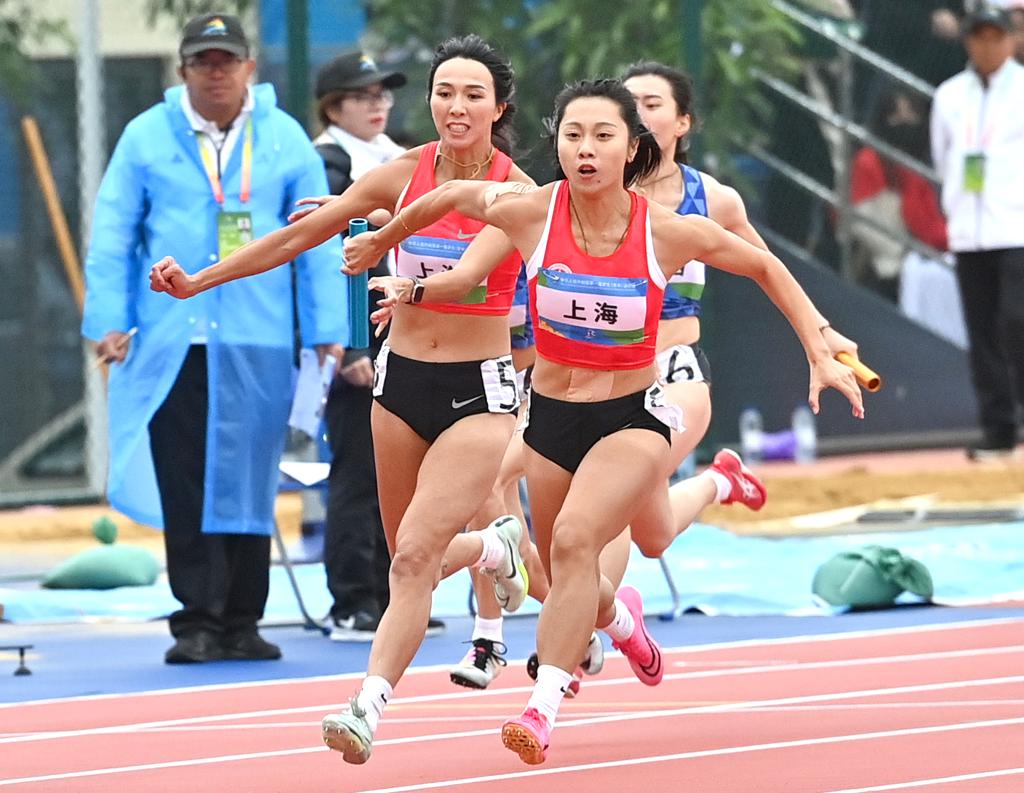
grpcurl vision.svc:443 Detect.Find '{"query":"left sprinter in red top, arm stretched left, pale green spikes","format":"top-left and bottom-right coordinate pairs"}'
top-left (151, 36), bottom-right (531, 763)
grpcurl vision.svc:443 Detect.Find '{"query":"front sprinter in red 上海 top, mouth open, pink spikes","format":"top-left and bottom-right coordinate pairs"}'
top-left (346, 80), bottom-right (863, 763)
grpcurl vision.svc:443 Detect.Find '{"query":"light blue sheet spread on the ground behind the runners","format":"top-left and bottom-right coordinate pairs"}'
top-left (0, 523), bottom-right (1024, 623)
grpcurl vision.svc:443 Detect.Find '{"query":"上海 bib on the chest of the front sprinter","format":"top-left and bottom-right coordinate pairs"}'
top-left (537, 268), bottom-right (648, 345)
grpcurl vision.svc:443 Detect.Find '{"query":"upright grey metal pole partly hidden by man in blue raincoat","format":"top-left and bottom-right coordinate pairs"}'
top-left (75, 0), bottom-right (108, 495)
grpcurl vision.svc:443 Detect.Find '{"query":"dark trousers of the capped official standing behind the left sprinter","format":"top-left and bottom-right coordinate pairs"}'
top-left (324, 376), bottom-right (391, 619)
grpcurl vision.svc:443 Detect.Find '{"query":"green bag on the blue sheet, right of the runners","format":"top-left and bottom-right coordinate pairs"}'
top-left (811, 545), bottom-right (933, 609)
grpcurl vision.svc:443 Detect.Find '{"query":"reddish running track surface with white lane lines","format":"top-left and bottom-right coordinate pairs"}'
top-left (0, 618), bottom-right (1024, 793)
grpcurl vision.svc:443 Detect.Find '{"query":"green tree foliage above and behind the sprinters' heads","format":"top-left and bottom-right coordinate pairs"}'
top-left (368, 0), bottom-right (800, 178)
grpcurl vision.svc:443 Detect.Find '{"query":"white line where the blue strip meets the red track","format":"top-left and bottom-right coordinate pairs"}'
top-left (6, 617), bottom-right (1024, 710)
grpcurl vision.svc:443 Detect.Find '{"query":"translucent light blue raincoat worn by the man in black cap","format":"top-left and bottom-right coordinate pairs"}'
top-left (82, 85), bottom-right (348, 535)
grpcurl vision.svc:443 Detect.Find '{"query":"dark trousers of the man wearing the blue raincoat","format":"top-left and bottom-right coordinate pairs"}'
top-left (150, 344), bottom-right (270, 637)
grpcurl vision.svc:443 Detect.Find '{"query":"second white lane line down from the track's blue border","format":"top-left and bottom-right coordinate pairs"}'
top-left (8, 644), bottom-right (1024, 745)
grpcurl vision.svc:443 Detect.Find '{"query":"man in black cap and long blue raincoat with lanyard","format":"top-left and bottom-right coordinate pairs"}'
top-left (83, 14), bottom-right (348, 663)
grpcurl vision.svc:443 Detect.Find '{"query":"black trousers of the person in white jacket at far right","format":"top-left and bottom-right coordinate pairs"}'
top-left (956, 248), bottom-right (1024, 446)
